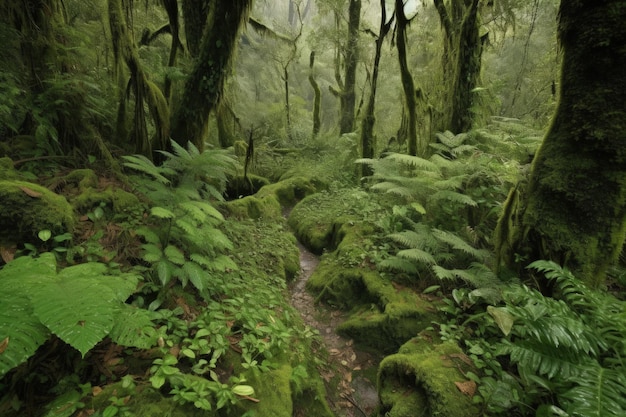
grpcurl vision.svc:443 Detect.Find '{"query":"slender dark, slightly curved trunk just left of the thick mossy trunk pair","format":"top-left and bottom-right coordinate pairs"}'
top-left (395, 0), bottom-right (418, 155)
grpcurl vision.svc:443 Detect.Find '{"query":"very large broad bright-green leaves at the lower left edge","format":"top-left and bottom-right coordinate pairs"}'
top-left (0, 253), bottom-right (150, 377)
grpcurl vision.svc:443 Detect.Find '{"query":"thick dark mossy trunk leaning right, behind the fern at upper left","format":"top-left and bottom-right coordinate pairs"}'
top-left (171, 0), bottom-right (252, 149)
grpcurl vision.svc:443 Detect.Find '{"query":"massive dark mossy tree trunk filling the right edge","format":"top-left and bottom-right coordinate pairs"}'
top-left (499, 0), bottom-right (626, 287)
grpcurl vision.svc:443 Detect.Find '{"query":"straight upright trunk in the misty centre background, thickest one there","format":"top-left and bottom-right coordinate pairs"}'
top-left (339, 0), bottom-right (361, 134)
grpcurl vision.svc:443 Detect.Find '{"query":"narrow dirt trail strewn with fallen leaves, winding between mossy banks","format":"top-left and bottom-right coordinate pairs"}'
top-left (289, 243), bottom-right (379, 417)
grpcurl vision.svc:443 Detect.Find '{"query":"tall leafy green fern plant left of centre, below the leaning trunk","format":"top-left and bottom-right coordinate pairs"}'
top-left (125, 142), bottom-right (236, 293)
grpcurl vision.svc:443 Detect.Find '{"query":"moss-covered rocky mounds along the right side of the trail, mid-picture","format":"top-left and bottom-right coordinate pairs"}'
top-left (289, 188), bottom-right (436, 353)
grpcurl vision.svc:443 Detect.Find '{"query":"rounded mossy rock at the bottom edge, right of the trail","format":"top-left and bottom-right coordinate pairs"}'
top-left (378, 341), bottom-right (481, 417)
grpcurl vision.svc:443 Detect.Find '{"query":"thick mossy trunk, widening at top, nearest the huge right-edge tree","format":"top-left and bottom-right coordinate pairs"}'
top-left (434, 0), bottom-right (484, 133)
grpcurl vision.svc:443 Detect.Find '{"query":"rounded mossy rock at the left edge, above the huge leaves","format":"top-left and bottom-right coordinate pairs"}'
top-left (0, 181), bottom-right (76, 243)
